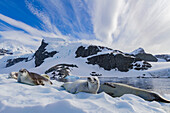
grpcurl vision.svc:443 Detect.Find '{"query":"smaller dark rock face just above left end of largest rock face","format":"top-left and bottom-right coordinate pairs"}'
top-left (75, 45), bottom-right (112, 58)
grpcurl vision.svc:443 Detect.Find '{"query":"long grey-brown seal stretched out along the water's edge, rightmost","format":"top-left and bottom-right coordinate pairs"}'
top-left (100, 82), bottom-right (170, 103)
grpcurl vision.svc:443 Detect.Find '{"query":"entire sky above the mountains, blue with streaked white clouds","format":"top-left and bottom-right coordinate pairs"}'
top-left (0, 0), bottom-right (170, 53)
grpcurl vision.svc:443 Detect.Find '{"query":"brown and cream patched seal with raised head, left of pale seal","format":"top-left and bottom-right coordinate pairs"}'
top-left (17, 69), bottom-right (52, 86)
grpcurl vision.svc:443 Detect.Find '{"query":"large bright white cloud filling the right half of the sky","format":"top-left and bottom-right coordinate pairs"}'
top-left (88, 0), bottom-right (170, 53)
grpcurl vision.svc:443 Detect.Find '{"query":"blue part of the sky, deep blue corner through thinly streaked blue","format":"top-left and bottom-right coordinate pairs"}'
top-left (0, 0), bottom-right (93, 38)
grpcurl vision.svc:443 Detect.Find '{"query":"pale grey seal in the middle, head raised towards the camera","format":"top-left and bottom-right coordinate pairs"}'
top-left (61, 77), bottom-right (100, 94)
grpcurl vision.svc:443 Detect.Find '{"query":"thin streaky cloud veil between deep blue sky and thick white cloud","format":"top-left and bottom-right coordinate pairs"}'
top-left (26, 0), bottom-right (93, 39)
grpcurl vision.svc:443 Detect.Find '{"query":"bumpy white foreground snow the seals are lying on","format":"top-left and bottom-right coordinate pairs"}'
top-left (0, 74), bottom-right (170, 113)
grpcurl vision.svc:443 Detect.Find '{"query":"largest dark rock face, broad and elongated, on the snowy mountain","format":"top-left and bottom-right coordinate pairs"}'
top-left (87, 53), bottom-right (151, 72)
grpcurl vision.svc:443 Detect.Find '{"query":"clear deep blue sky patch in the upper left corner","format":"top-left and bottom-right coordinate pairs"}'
top-left (0, 0), bottom-right (41, 29)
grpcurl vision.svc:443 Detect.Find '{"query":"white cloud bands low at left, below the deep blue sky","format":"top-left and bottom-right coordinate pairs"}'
top-left (0, 14), bottom-right (67, 51)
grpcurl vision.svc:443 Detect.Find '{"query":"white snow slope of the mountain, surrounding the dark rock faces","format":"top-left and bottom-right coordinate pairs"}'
top-left (0, 38), bottom-right (170, 78)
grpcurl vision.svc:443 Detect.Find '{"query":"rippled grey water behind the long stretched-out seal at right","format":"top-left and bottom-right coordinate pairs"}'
top-left (99, 77), bottom-right (170, 94)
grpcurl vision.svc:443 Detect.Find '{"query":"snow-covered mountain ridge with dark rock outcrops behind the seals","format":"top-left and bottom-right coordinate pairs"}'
top-left (0, 38), bottom-right (170, 77)
